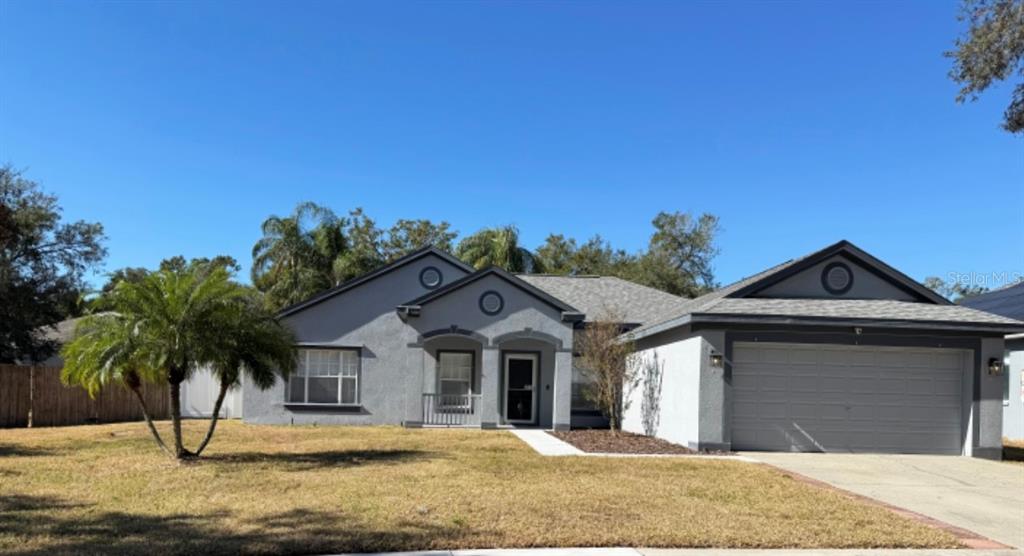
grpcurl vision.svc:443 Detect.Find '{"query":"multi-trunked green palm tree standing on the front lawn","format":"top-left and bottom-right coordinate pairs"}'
top-left (62, 265), bottom-right (295, 459)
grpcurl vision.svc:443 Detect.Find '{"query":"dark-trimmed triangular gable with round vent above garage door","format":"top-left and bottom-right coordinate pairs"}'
top-left (720, 240), bottom-right (950, 305)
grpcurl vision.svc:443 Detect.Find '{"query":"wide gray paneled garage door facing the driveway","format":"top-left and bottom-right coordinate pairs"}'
top-left (732, 342), bottom-right (970, 454)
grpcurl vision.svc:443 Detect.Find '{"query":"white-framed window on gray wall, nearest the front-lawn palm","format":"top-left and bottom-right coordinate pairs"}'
top-left (288, 349), bottom-right (359, 405)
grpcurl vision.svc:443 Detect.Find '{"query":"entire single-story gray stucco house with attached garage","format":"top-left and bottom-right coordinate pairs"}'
top-left (243, 242), bottom-right (1024, 457)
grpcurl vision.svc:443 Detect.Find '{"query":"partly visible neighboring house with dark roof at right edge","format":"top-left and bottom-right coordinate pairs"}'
top-left (962, 282), bottom-right (1024, 440)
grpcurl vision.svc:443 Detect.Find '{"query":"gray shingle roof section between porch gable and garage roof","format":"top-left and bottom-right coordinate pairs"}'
top-left (518, 274), bottom-right (690, 325)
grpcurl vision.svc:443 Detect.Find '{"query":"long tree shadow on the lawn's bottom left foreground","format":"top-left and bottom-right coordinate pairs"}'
top-left (0, 496), bottom-right (478, 556)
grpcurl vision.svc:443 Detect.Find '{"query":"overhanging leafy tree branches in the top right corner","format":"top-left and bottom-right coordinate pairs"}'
top-left (946, 0), bottom-right (1024, 133)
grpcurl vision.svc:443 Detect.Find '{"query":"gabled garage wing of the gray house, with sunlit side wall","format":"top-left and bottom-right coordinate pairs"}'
top-left (624, 241), bottom-right (1024, 458)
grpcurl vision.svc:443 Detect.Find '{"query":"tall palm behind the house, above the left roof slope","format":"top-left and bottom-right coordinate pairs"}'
top-left (252, 203), bottom-right (346, 308)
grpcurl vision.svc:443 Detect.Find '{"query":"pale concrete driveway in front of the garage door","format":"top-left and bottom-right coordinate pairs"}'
top-left (745, 452), bottom-right (1024, 548)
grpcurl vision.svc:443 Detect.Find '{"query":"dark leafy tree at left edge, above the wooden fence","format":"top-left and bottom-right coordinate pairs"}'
top-left (0, 166), bottom-right (106, 362)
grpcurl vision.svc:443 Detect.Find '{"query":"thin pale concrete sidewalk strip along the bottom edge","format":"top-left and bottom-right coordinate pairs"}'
top-left (331, 548), bottom-right (1024, 556)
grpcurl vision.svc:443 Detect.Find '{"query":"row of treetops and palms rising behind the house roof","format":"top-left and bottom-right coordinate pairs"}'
top-left (253, 203), bottom-right (719, 309)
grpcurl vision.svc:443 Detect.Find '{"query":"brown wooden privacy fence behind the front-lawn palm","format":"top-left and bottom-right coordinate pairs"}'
top-left (0, 365), bottom-right (170, 427)
